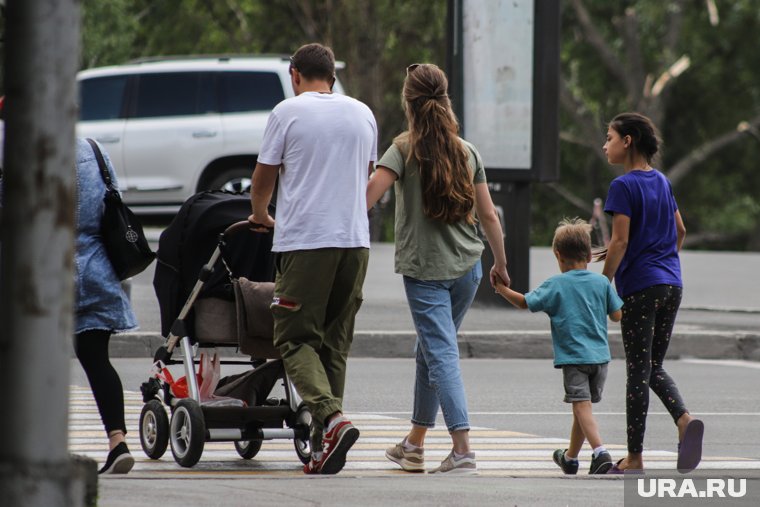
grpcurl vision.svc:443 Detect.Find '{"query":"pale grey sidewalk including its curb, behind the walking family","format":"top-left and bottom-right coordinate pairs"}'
top-left (111, 243), bottom-right (760, 360)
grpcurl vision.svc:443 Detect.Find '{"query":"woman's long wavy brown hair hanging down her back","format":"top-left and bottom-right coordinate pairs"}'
top-left (397, 64), bottom-right (475, 224)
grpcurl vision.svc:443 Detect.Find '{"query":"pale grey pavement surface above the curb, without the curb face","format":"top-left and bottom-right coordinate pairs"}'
top-left (131, 238), bottom-right (760, 342)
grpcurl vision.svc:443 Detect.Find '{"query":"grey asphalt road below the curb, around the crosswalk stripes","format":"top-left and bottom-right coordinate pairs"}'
top-left (72, 359), bottom-right (760, 507)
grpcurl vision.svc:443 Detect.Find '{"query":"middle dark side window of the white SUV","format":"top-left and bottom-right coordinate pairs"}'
top-left (132, 72), bottom-right (217, 118)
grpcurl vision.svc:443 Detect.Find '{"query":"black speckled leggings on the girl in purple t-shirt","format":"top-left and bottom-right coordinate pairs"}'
top-left (620, 285), bottom-right (688, 454)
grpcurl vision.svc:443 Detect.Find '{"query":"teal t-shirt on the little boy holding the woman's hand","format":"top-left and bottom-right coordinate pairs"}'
top-left (525, 269), bottom-right (623, 368)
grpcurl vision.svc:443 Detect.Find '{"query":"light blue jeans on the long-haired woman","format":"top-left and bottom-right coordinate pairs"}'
top-left (404, 261), bottom-right (483, 432)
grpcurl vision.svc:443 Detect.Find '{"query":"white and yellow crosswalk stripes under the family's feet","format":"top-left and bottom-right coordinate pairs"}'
top-left (69, 386), bottom-right (760, 477)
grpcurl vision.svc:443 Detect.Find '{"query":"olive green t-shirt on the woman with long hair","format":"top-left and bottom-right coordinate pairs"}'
top-left (377, 140), bottom-right (486, 280)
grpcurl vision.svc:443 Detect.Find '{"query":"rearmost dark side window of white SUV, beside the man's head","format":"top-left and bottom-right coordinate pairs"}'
top-left (220, 72), bottom-right (285, 113)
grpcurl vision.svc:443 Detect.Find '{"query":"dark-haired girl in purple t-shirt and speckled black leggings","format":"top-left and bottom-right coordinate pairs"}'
top-left (603, 113), bottom-right (704, 473)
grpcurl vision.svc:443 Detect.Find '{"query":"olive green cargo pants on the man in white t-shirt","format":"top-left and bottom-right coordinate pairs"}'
top-left (272, 248), bottom-right (369, 430)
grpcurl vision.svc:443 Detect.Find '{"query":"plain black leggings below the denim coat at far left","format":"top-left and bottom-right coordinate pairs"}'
top-left (74, 329), bottom-right (127, 435)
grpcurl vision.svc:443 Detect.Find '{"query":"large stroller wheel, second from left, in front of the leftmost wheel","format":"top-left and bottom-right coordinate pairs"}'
top-left (169, 398), bottom-right (206, 467)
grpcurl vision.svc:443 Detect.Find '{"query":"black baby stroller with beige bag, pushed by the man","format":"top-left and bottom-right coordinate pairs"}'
top-left (139, 191), bottom-right (311, 467)
